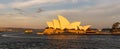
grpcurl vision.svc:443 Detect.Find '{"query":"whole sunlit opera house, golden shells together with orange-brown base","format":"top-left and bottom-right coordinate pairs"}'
top-left (43, 15), bottom-right (91, 34)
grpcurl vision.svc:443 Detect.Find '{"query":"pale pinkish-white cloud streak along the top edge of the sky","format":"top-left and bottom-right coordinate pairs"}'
top-left (10, 0), bottom-right (118, 8)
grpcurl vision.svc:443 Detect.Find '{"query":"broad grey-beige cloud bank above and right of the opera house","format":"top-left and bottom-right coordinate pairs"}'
top-left (39, 3), bottom-right (120, 28)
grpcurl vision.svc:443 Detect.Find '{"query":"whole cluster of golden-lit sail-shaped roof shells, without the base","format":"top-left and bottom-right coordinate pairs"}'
top-left (47, 15), bottom-right (91, 31)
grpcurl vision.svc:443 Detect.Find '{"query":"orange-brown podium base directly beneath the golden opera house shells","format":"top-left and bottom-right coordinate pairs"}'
top-left (37, 28), bottom-right (98, 35)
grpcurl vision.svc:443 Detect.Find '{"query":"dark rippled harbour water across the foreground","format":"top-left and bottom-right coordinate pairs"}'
top-left (0, 34), bottom-right (120, 49)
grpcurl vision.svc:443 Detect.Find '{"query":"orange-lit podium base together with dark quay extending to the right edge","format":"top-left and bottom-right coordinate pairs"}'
top-left (37, 28), bottom-right (120, 35)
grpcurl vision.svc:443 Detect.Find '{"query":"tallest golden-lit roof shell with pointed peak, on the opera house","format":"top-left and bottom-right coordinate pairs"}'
top-left (58, 15), bottom-right (70, 29)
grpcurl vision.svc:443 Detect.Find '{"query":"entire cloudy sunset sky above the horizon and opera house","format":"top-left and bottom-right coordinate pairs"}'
top-left (0, 0), bottom-right (120, 29)
